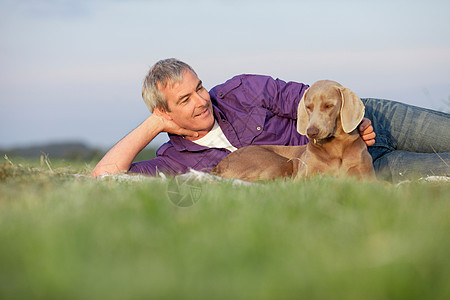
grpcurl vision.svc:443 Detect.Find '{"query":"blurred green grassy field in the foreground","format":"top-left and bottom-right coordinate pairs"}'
top-left (0, 161), bottom-right (450, 299)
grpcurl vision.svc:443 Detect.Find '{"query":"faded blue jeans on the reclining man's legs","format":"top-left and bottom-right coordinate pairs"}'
top-left (361, 98), bottom-right (450, 181)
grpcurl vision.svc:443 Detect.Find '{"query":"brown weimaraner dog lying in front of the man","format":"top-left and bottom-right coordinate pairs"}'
top-left (212, 80), bottom-right (375, 181)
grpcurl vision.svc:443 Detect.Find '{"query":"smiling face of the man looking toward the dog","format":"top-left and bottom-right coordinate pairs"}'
top-left (161, 71), bottom-right (214, 132)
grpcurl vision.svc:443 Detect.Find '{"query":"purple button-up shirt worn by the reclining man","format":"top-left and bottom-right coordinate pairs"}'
top-left (129, 75), bottom-right (308, 175)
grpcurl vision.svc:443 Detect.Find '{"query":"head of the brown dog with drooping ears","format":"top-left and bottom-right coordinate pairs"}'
top-left (297, 80), bottom-right (364, 140)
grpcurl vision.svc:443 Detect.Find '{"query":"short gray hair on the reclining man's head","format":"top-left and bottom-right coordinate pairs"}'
top-left (142, 58), bottom-right (197, 113)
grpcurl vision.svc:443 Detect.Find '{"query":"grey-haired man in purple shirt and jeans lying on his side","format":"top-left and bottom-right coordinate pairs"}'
top-left (92, 59), bottom-right (450, 179)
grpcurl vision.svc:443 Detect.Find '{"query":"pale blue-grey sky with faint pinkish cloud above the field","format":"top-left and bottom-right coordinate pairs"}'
top-left (0, 0), bottom-right (450, 149)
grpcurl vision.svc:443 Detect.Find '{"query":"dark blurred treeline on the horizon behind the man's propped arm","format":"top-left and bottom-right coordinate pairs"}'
top-left (0, 142), bottom-right (156, 161)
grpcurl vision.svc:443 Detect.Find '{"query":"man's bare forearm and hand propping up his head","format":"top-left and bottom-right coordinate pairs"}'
top-left (91, 109), bottom-right (197, 177)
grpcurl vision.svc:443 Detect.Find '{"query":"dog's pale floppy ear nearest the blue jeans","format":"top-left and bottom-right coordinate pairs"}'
top-left (339, 87), bottom-right (364, 133)
